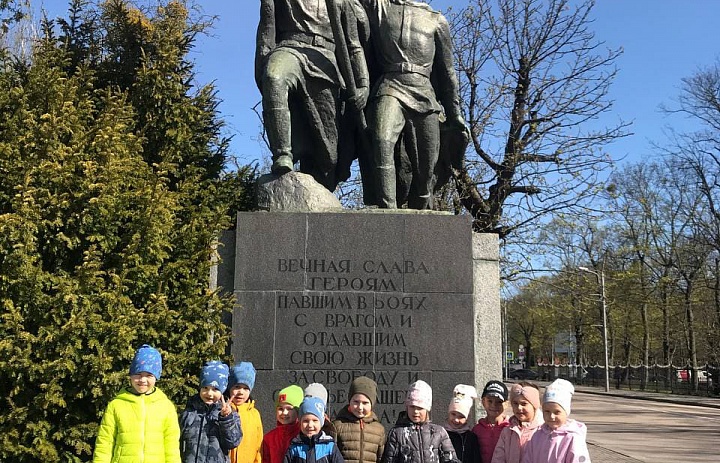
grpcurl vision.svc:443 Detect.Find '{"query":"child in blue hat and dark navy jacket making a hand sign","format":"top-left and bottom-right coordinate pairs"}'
top-left (180, 360), bottom-right (242, 463)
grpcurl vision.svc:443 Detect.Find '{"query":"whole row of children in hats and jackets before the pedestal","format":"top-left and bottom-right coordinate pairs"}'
top-left (93, 345), bottom-right (590, 463)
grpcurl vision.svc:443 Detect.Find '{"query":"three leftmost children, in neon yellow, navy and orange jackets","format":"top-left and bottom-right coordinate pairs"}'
top-left (93, 344), bottom-right (263, 463)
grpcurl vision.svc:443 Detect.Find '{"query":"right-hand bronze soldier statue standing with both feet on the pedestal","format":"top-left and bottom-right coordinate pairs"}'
top-left (360, 0), bottom-right (467, 209)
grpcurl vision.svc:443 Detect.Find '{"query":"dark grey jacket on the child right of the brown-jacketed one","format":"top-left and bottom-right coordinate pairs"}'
top-left (381, 412), bottom-right (458, 463)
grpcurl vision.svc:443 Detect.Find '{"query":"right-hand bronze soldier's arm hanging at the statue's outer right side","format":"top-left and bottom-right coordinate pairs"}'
top-left (433, 15), bottom-right (465, 127)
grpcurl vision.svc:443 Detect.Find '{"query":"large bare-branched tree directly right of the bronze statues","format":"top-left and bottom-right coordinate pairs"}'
top-left (450, 0), bottom-right (628, 238)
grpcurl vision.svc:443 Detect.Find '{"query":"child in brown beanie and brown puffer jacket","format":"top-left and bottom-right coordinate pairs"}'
top-left (333, 376), bottom-right (385, 463)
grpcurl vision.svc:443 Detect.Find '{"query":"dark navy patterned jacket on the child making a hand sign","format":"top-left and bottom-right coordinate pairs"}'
top-left (180, 395), bottom-right (242, 463)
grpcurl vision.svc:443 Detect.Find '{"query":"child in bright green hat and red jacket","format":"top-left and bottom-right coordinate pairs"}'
top-left (261, 384), bottom-right (303, 463)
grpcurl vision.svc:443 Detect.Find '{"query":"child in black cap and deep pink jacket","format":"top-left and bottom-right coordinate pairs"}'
top-left (473, 380), bottom-right (510, 463)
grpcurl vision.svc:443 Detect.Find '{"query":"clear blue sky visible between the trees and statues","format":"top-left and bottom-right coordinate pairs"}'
top-left (33, 0), bottom-right (720, 169)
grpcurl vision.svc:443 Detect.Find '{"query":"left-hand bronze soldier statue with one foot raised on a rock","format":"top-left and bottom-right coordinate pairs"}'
top-left (255, 0), bottom-right (369, 191)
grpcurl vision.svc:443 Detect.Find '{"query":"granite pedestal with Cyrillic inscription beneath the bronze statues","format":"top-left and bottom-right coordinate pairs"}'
top-left (218, 212), bottom-right (502, 431)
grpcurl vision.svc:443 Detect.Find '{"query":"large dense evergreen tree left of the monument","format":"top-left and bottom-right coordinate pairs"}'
top-left (0, 0), bottom-right (254, 462)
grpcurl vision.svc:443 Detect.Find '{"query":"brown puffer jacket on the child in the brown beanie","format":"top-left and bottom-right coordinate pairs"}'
top-left (333, 407), bottom-right (385, 463)
